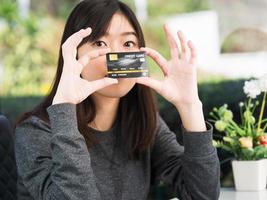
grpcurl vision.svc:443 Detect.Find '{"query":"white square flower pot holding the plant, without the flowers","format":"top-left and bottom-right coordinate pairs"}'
top-left (232, 159), bottom-right (267, 191)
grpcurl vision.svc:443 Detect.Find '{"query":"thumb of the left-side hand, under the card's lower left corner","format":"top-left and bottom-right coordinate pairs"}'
top-left (87, 77), bottom-right (118, 94)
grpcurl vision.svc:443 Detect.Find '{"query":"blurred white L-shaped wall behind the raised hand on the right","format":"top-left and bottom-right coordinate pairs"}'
top-left (167, 11), bottom-right (267, 78)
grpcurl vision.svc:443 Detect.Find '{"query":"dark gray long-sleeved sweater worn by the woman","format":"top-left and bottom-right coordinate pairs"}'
top-left (15, 103), bottom-right (220, 200)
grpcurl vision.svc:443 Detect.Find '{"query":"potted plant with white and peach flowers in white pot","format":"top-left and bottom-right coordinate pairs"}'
top-left (210, 75), bottom-right (267, 191)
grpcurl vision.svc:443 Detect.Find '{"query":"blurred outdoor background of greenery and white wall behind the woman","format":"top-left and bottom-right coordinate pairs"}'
top-left (0, 0), bottom-right (267, 199)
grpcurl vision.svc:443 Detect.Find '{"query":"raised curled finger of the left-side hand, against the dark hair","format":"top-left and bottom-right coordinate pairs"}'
top-left (62, 27), bottom-right (92, 59)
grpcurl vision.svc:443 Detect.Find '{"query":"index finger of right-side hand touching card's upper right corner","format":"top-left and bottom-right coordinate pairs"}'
top-left (140, 47), bottom-right (168, 76)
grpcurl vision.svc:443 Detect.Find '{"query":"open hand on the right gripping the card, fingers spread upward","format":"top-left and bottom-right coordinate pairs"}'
top-left (137, 25), bottom-right (200, 107)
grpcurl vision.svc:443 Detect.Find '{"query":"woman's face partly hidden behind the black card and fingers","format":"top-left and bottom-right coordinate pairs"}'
top-left (78, 13), bottom-right (139, 98)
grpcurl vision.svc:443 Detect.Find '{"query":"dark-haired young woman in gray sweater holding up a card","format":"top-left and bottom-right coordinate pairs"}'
top-left (16, 0), bottom-right (220, 200)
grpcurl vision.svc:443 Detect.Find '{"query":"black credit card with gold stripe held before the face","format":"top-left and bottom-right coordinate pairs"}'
top-left (106, 51), bottom-right (149, 78)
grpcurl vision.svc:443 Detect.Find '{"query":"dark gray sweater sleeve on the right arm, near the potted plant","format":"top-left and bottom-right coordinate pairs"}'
top-left (151, 117), bottom-right (220, 200)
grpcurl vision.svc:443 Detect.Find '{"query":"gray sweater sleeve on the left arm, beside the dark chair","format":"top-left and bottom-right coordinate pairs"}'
top-left (15, 103), bottom-right (100, 200)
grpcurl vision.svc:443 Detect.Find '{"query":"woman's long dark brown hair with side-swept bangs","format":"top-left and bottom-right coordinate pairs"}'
top-left (16, 0), bottom-right (157, 159)
